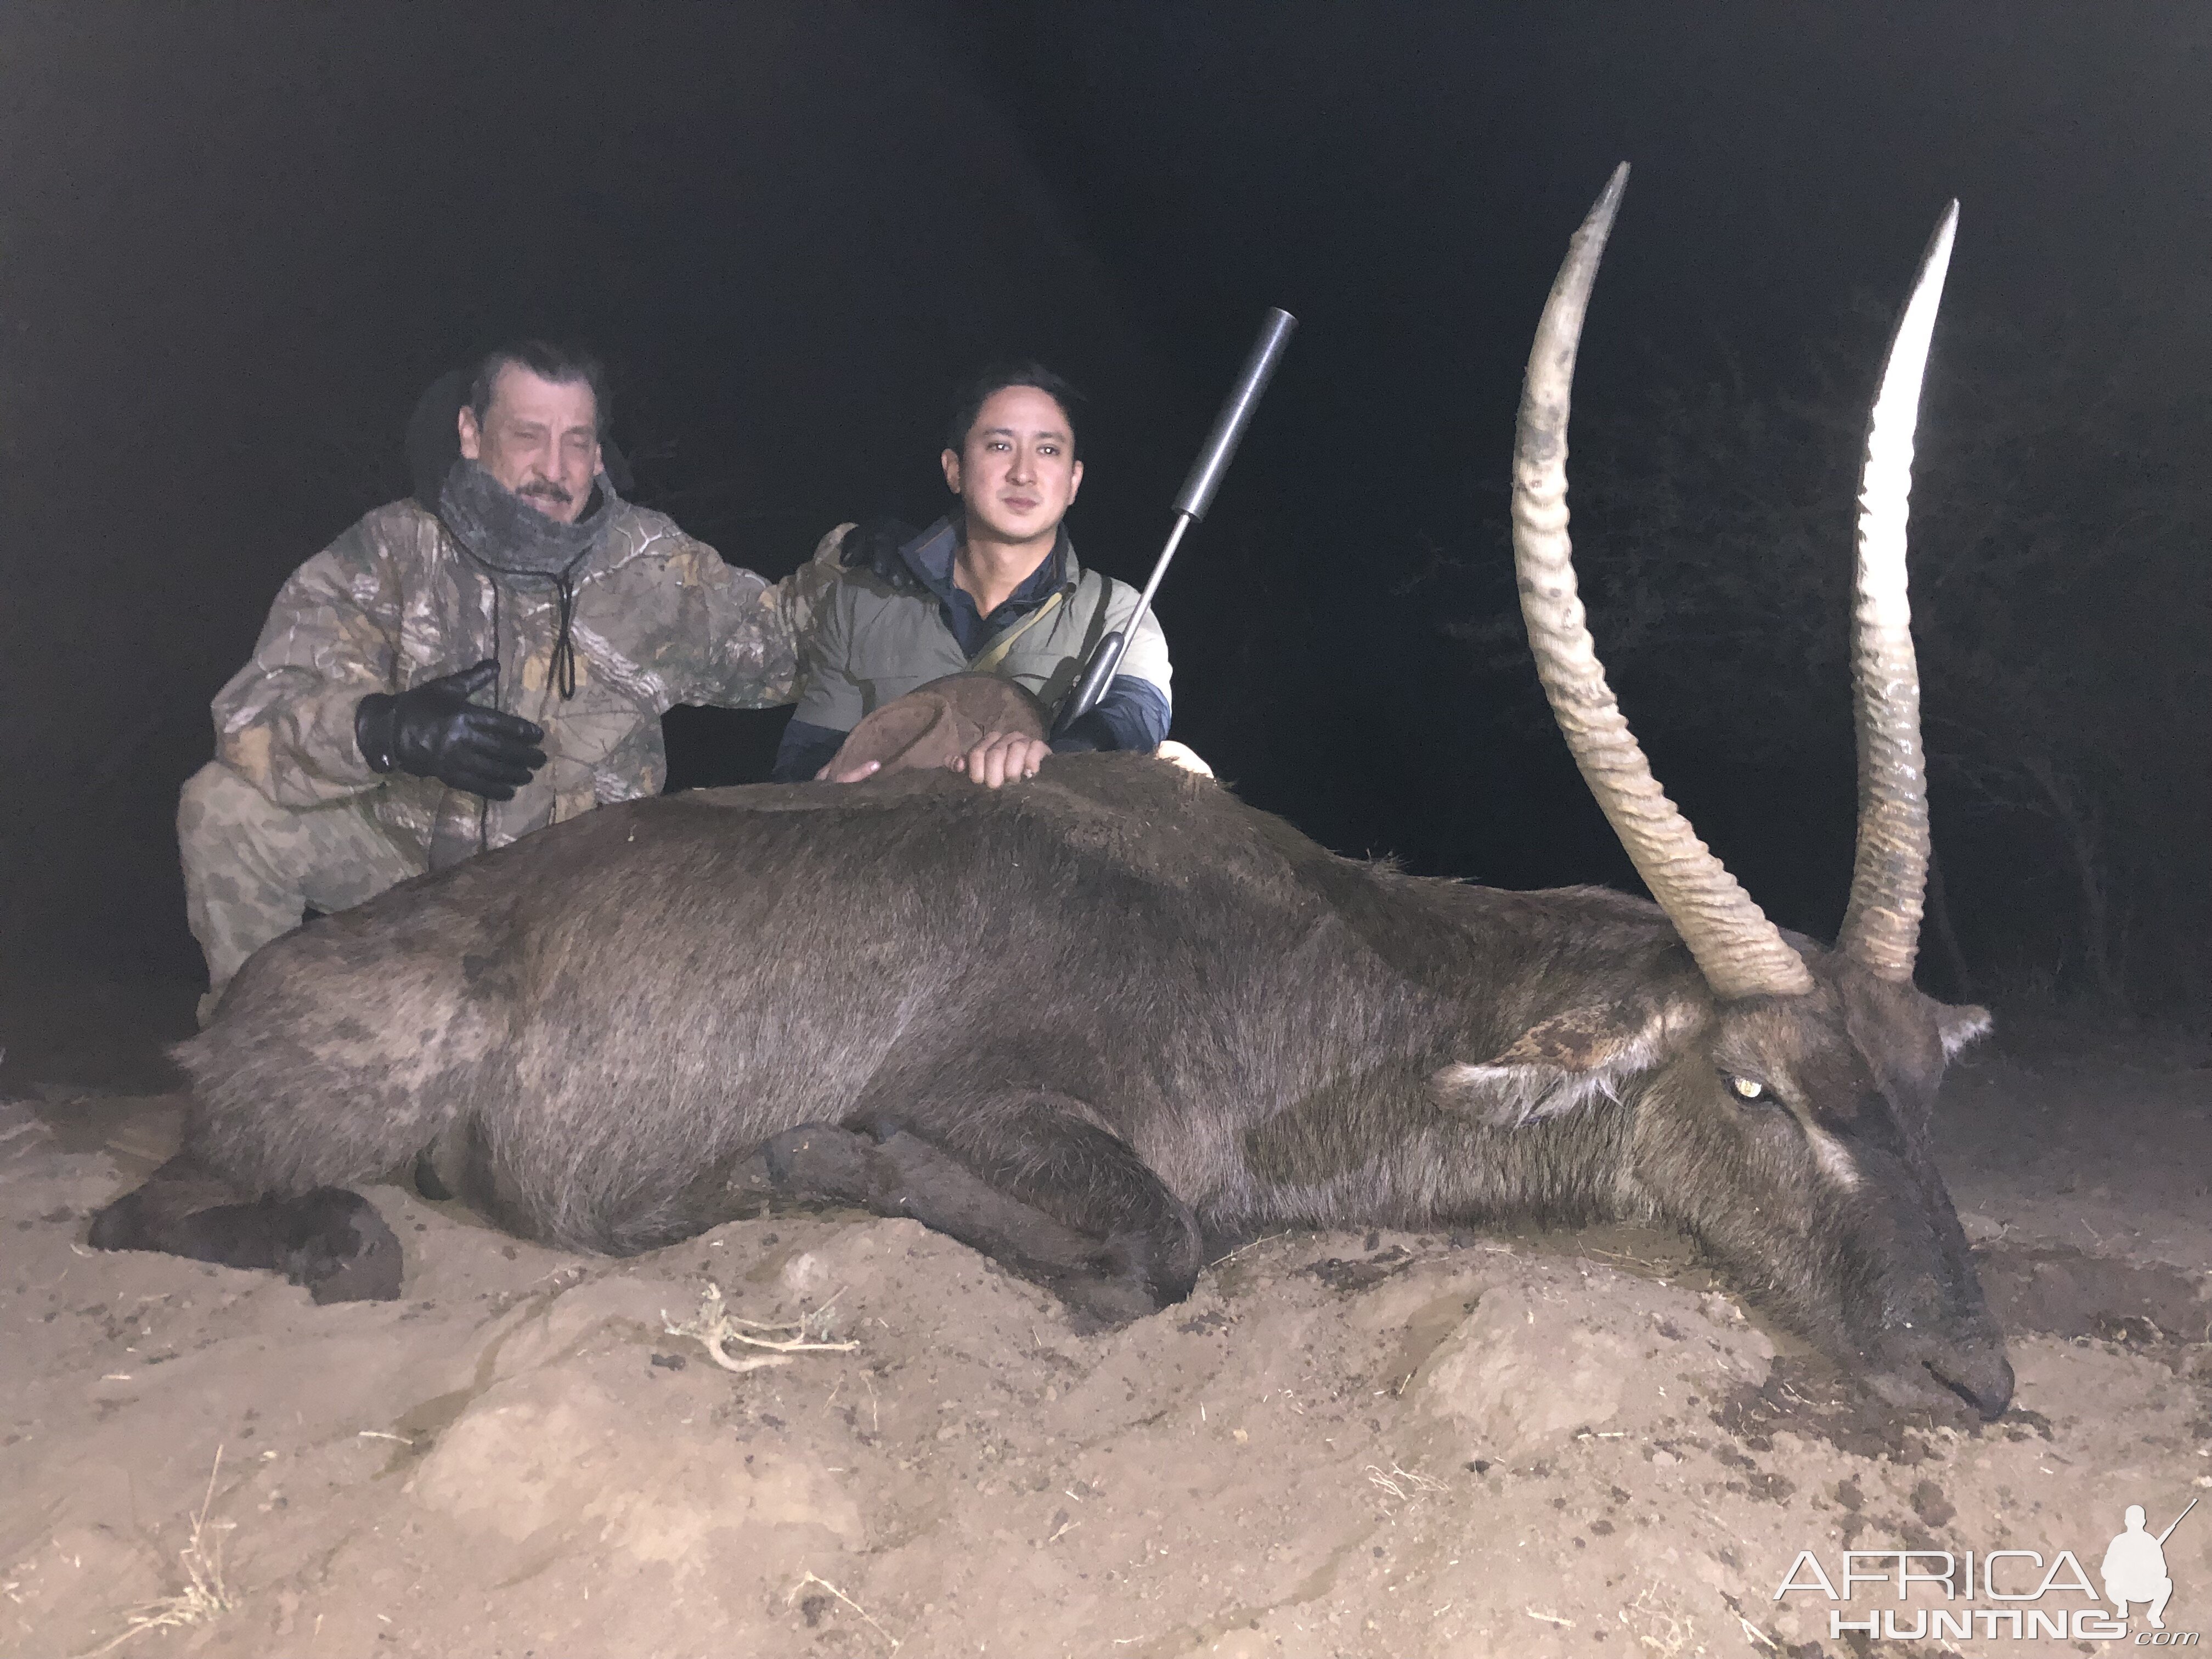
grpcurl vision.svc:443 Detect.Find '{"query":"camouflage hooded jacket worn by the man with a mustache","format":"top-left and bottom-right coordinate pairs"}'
top-left (215, 500), bottom-right (838, 867)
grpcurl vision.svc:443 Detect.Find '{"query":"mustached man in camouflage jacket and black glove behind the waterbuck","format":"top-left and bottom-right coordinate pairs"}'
top-left (177, 343), bottom-right (836, 1020)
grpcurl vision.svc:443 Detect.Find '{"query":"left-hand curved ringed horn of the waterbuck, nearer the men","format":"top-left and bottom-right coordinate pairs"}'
top-left (1513, 161), bottom-right (1812, 1000)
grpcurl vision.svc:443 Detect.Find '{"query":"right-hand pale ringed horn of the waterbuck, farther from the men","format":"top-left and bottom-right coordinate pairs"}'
top-left (1836, 201), bottom-right (1957, 984)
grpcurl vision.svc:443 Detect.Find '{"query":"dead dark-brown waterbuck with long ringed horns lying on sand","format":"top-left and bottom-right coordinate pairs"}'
top-left (91, 168), bottom-right (2013, 1415)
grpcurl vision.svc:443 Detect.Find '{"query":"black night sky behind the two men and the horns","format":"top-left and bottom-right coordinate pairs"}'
top-left (0, 0), bottom-right (2212, 1079)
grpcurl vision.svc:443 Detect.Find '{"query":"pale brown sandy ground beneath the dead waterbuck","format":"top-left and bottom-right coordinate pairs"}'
top-left (0, 1033), bottom-right (2212, 1659)
